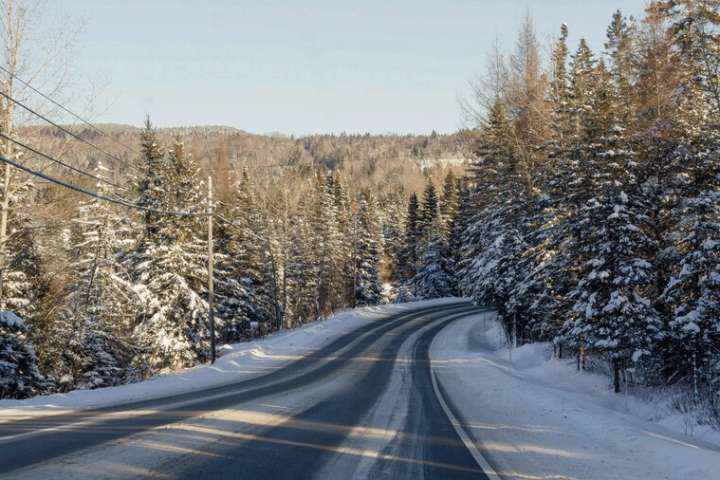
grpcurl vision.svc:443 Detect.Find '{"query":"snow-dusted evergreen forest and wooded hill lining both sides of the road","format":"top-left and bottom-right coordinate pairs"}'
top-left (0, 0), bottom-right (720, 432)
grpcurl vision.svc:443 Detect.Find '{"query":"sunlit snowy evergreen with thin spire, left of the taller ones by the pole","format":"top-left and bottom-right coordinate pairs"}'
top-left (52, 163), bottom-right (137, 389)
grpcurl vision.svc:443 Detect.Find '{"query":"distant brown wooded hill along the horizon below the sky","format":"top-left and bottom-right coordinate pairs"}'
top-left (14, 123), bottom-right (469, 199)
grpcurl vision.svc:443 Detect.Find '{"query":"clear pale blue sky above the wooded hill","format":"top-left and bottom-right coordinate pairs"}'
top-left (54, 0), bottom-right (645, 135)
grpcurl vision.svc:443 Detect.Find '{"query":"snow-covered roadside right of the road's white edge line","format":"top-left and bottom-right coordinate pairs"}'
top-left (431, 313), bottom-right (720, 480)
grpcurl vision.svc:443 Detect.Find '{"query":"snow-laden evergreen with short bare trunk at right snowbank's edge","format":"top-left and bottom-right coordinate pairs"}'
top-left (571, 191), bottom-right (661, 389)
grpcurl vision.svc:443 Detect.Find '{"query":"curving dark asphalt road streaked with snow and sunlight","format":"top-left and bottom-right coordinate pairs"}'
top-left (0, 303), bottom-right (488, 480)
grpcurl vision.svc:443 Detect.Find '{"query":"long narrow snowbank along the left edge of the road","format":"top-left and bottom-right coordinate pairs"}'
top-left (0, 299), bottom-right (461, 421)
